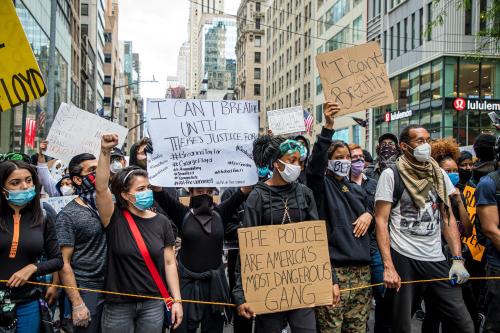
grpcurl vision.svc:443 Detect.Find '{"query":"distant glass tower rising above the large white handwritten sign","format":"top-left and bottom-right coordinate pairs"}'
top-left (202, 18), bottom-right (236, 90)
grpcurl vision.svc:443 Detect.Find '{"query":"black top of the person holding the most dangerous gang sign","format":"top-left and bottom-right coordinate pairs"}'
top-left (233, 182), bottom-right (318, 305)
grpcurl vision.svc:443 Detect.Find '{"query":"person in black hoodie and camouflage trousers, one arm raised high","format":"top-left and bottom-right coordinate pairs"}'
top-left (307, 102), bottom-right (373, 332)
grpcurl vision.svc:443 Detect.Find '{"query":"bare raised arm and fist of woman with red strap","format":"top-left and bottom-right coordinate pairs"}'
top-left (95, 134), bottom-right (118, 227)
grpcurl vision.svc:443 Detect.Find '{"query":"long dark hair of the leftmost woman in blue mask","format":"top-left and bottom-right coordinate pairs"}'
top-left (0, 161), bottom-right (44, 231)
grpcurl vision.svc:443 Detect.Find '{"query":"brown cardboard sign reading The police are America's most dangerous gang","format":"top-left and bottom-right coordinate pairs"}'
top-left (238, 221), bottom-right (333, 314)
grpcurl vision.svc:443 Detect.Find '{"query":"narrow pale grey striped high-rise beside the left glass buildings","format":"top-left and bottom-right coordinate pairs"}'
top-left (80, 0), bottom-right (106, 112)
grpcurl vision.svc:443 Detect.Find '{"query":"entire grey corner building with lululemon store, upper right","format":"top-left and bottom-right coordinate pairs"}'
top-left (366, 0), bottom-right (500, 146)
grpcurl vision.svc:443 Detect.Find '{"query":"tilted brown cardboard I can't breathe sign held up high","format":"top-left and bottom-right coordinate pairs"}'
top-left (316, 42), bottom-right (394, 116)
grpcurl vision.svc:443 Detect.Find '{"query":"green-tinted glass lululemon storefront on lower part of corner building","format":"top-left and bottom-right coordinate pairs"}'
top-left (372, 56), bottom-right (500, 148)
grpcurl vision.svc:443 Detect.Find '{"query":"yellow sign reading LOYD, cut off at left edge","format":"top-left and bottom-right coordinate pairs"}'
top-left (0, 1), bottom-right (47, 111)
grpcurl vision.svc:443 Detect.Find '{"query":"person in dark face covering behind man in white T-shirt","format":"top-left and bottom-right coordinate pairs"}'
top-left (365, 133), bottom-right (401, 180)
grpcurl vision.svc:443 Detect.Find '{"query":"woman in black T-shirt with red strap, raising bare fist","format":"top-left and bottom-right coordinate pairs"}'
top-left (96, 134), bottom-right (183, 333)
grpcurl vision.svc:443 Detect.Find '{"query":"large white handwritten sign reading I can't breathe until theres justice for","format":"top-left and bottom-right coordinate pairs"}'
top-left (147, 99), bottom-right (259, 187)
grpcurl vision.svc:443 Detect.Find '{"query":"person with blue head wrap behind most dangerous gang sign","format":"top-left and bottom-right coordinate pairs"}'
top-left (233, 135), bottom-right (318, 333)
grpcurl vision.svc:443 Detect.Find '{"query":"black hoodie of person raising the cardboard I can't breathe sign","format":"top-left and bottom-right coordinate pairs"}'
top-left (307, 128), bottom-right (371, 267)
